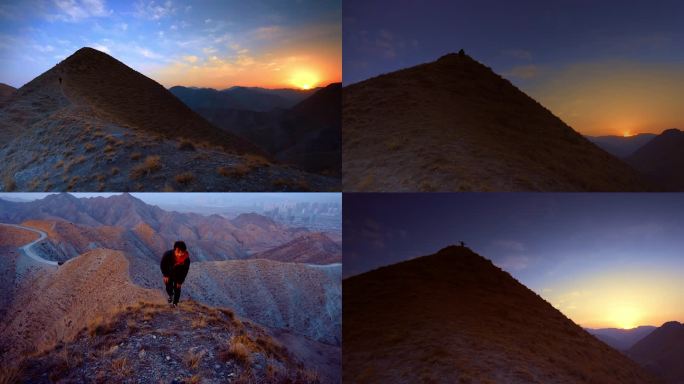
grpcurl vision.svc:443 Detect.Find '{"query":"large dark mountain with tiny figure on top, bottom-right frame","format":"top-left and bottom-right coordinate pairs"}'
top-left (342, 246), bottom-right (654, 384)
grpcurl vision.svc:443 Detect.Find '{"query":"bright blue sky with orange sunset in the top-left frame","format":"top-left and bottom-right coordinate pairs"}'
top-left (0, 0), bottom-right (342, 89)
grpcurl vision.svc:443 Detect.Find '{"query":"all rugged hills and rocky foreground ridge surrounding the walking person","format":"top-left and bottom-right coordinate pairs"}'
top-left (0, 194), bottom-right (341, 383)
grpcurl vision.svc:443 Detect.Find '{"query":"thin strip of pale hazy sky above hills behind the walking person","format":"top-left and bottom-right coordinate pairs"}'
top-left (0, 192), bottom-right (342, 211)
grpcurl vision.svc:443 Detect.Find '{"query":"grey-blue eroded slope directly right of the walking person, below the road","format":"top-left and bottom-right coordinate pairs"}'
top-left (184, 260), bottom-right (342, 345)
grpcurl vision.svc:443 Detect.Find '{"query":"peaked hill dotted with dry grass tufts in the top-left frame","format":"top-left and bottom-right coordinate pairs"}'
top-left (0, 48), bottom-right (338, 191)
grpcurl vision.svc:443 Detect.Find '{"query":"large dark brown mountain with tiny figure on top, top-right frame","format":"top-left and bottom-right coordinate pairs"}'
top-left (342, 54), bottom-right (646, 191)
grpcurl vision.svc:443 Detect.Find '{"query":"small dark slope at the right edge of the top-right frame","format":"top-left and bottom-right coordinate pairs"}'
top-left (625, 129), bottom-right (684, 191)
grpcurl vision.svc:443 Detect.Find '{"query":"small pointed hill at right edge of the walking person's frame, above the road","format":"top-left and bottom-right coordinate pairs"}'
top-left (250, 232), bottom-right (342, 264)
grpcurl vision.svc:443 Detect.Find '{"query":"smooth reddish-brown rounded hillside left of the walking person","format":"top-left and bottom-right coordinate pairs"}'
top-left (0, 249), bottom-right (164, 362)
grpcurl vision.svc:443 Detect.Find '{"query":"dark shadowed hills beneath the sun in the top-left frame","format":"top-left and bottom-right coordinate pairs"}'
top-left (171, 83), bottom-right (342, 176)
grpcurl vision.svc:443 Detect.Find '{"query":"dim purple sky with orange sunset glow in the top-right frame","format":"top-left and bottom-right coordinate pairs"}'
top-left (343, 0), bottom-right (684, 135)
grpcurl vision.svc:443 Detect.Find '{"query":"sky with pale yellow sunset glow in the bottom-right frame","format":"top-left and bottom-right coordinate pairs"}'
top-left (342, 193), bottom-right (684, 328)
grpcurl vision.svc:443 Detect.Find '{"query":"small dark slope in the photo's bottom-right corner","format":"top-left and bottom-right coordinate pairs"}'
top-left (627, 321), bottom-right (684, 384)
